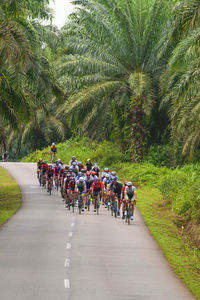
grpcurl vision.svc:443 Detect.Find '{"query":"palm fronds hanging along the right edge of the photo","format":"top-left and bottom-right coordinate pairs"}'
top-left (162, 0), bottom-right (200, 160)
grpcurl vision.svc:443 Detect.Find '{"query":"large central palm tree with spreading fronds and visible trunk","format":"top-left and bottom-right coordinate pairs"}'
top-left (57, 0), bottom-right (172, 161)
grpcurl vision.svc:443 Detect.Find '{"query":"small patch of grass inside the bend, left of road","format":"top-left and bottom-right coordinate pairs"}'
top-left (0, 168), bottom-right (21, 226)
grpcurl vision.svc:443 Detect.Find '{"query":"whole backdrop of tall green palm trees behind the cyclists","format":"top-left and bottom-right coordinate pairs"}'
top-left (0, 0), bottom-right (200, 166)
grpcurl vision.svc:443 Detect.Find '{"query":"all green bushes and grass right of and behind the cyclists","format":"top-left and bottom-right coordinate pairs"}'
top-left (23, 138), bottom-right (200, 299)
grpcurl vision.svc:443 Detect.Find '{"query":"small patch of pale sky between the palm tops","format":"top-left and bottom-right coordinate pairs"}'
top-left (50, 0), bottom-right (73, 28)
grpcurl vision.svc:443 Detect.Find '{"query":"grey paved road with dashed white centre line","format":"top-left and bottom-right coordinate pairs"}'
top-left (0, 163), bottom-right (194, 300)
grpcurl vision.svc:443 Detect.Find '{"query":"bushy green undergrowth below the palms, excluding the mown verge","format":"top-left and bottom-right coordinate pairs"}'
top-left (23, 138), bottom-right (200, 223)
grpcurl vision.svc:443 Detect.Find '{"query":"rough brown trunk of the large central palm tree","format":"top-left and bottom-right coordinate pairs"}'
top-left (131, 98), bottom-right (146, 162)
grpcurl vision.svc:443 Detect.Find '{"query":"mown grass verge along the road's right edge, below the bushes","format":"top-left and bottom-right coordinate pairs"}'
top-left (137, 188), bottom-right (200, 300)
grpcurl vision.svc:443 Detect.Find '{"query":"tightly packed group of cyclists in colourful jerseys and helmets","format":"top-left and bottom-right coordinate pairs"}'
top-left (37, 144), bottom-right (136, 220)
